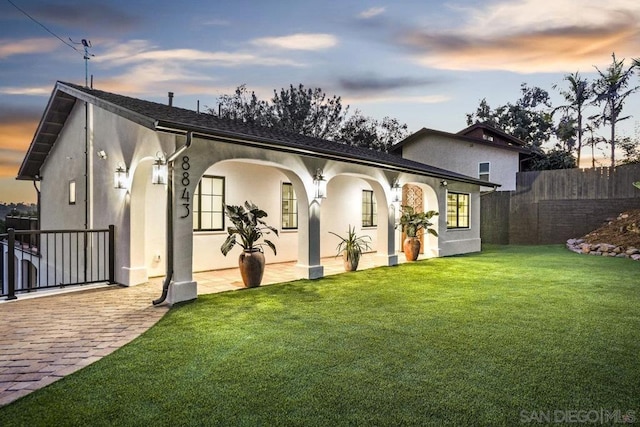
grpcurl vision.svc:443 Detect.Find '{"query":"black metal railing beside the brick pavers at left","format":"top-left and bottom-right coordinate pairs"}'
top-left (0, 225), bottom-right (115, 299)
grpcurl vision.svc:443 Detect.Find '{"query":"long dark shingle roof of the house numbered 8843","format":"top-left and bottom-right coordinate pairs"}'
top-left (18, 82), bottom-right (491, 186)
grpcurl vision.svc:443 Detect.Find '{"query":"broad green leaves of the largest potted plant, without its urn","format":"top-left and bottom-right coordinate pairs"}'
top-left (220, 201), bottom-right (278, 256)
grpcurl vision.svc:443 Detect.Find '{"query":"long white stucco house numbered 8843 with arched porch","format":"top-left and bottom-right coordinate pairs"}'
top-left (18, 82), bottom-right (493, 304)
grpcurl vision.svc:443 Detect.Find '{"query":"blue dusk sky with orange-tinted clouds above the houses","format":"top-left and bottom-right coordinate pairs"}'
top-left (0, 0), bottom-right (640, 202)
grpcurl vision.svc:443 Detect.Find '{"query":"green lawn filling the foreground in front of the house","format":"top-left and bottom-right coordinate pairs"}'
top-left (0, 246), bottom-right (640, 426)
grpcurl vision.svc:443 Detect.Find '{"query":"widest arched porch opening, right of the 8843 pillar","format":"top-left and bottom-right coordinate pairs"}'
top-left (192, 159), bottom-right (308, 272)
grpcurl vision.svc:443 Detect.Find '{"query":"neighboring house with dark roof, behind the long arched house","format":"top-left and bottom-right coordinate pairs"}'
top-left (391, 123), bottom-right (531, 191)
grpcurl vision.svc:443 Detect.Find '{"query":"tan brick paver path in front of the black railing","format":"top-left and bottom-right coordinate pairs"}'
top-left (0, 282), bottom-right (168, 406)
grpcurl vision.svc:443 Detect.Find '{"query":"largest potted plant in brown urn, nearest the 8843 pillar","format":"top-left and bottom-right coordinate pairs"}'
top-left (220, 201), bottom-right (278, 288)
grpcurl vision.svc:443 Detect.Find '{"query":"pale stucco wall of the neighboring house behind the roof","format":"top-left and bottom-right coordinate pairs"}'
top-left (402, 134), bottom-right (520, 191)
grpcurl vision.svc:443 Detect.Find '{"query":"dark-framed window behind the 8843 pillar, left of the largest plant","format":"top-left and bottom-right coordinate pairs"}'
top-left (193, 175), bottom-right (224, 231)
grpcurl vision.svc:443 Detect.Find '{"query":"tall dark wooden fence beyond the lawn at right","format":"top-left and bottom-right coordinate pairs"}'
top-left (481, 165), bottom-right (640, 244)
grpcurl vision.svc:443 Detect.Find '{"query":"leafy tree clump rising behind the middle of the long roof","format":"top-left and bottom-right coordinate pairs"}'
top-left (207, 84), bottom-right (407, 151)
